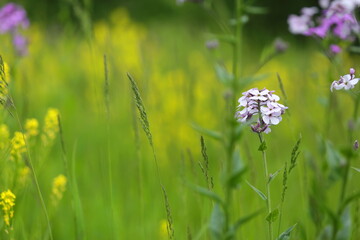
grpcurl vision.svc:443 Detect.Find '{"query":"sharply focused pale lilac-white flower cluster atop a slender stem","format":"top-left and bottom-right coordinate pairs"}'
top-left (236, 88), bottom-right (287, 133)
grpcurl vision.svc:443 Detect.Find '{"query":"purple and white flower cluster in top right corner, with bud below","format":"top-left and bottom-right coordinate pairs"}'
top-left (288, 0), bottom-right (360, 53)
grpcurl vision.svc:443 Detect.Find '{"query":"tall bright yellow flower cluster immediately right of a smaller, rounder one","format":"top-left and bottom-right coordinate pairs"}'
top-left (41, 108), bottom-right (59, 146)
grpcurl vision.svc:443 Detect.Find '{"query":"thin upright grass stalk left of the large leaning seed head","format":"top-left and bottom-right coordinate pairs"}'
top-left (104, 54), bottom-right (117, 239)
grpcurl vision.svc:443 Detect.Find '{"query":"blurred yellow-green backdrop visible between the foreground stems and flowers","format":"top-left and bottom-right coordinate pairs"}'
top-left (0, 0), bottom-right (359, 239)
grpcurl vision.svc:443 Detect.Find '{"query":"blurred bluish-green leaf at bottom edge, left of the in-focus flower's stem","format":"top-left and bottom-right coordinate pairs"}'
top-left (209, 204), bottom-right (225, 240)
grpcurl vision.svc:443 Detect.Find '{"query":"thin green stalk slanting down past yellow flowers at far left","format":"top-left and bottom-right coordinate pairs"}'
top-left (9, 102), bottom-right (54, 240)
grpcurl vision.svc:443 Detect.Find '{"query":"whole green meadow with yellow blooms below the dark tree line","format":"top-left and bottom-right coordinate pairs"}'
top-left (0, 0), bottom-right (360, 240)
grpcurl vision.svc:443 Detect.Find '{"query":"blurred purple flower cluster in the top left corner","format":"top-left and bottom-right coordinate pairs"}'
top-left (0, 3), bottom-right (30, 56)
